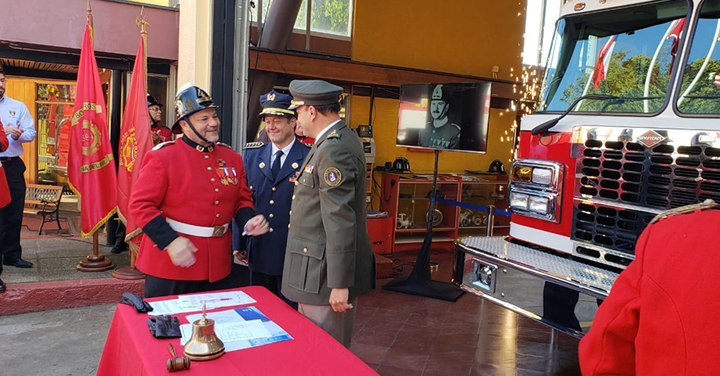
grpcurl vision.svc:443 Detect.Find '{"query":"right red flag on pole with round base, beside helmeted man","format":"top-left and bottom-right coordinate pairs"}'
top-left (112, 7), bottom-right (152, 279)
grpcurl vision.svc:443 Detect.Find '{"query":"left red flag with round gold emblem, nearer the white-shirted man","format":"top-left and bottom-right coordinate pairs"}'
top-left (68, 22), bottom-right (117, 236)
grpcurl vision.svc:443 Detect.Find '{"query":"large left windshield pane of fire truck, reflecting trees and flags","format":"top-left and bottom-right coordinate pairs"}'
top-left (537, 0), bottom-right (688, 113)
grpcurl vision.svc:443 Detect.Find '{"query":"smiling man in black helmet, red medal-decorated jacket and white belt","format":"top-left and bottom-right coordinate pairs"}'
top-left (129, 83), bottom-right (268, 297)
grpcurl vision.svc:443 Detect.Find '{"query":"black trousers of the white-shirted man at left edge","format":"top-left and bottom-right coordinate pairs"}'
top-left (0, 157), bottom-right (25, 274)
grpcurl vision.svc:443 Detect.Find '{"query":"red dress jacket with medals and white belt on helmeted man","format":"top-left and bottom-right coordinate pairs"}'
top-left (129, 138), bottom-right (253, 282)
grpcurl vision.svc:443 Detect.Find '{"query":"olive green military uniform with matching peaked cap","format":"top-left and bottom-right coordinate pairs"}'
top-left (282, 81), bottom-right (375, 347)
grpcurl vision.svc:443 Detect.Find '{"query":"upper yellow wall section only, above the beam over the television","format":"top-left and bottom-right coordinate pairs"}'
top-left (352, 0), bottom-right (527, 79)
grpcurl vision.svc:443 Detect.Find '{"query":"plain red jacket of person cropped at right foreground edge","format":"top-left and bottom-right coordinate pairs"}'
top-left (579, 210), bottom-right (720, 376)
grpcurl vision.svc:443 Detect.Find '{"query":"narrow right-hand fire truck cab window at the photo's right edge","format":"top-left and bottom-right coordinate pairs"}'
top-left (677, 0), bottom-right (720, 115)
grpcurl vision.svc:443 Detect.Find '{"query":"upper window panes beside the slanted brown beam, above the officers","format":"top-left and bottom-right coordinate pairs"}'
top-left (250, 0), bottom-right (353, 39)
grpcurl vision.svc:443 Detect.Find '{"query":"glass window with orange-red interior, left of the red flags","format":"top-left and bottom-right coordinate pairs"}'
top-left (35, 83), bottom-right (76, 185)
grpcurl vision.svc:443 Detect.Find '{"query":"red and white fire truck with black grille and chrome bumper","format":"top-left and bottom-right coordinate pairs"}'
top-left (454, 0), bottom-right (720, 338)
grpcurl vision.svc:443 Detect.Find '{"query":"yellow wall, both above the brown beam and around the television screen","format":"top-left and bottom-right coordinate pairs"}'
top-left (350, 0), bottom-right (525, 191)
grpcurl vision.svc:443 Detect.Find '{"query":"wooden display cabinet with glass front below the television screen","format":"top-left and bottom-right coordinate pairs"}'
top-left (380, 172), bottom-right (509, 253)
